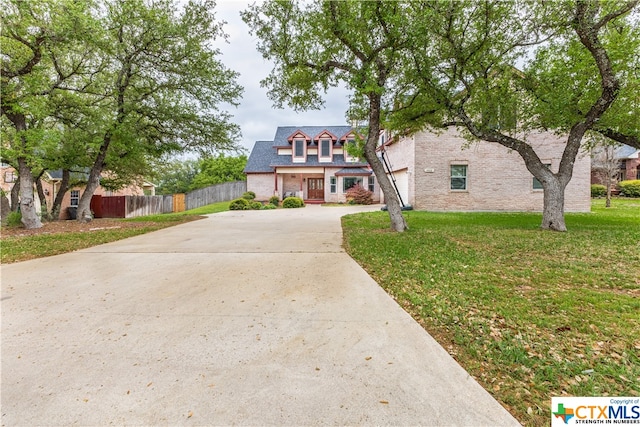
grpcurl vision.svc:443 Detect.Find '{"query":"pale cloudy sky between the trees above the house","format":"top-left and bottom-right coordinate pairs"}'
top-left (216, 0), bottom-right (347, 150)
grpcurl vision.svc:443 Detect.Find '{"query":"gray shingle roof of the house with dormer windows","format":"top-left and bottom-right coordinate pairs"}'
top-left (244, 126), bottom-right (376, 173)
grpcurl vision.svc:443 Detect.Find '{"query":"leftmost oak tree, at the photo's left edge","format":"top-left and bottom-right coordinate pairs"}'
top-left (0, 0), bottom-right (96, 228)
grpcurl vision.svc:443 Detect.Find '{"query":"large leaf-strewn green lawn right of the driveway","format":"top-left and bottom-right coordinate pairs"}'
top-left (343, 199), bottom-right (640, 426)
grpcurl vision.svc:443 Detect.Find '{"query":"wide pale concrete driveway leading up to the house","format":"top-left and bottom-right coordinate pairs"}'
top-left (0, 206), bottom-right (519, 426)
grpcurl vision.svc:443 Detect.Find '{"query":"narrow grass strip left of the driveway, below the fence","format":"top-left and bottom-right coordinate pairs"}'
top-left (0, 202), bottom-right (229, 264)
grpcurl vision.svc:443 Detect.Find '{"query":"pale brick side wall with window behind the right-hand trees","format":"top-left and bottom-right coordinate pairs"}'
top-left (387, 129), bottom-right (591, 212)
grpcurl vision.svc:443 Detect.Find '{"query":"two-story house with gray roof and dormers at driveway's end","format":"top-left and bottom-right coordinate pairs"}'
top-left (244, 126), bottom-right (380, 203)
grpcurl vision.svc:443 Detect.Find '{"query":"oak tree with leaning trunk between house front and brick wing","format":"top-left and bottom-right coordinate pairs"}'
top-left (243, 1), bottom-right (409, 231)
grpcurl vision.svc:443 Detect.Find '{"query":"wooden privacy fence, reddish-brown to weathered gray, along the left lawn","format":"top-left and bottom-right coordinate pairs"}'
top-left (91, 181), bottom-right (247, 218)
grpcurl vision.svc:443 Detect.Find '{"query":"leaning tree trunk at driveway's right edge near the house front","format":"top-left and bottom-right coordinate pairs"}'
top-left (364, 94), bottom-right (409, 232)
